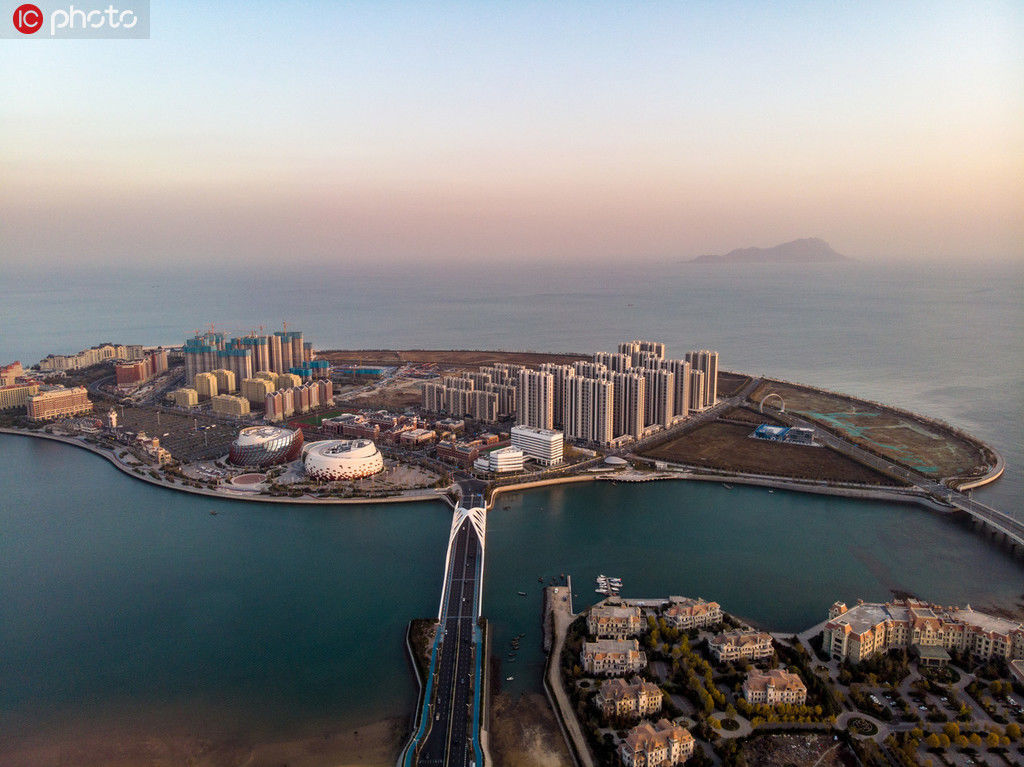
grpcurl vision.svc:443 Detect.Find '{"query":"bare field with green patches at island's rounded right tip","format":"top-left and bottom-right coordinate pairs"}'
top-left (751, 381), bottom-right (994, 478)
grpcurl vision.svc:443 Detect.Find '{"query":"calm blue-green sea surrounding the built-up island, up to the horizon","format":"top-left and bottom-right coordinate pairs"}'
top-left (0, 259), bottom-right (1024, 753)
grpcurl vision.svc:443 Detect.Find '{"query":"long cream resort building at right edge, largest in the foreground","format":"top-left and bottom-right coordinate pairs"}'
top-left (822, 599), bottom-right (1024, 663)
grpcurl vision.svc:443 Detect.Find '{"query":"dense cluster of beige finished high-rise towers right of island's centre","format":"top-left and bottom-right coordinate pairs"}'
top-left (423, 340), bottom-right (718, 444)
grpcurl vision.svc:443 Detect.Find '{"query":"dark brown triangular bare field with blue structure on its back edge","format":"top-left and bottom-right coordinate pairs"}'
top-left (641, 421), bottom-right (897, 485)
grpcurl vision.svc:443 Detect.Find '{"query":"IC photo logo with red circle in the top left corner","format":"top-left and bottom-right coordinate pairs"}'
top-left (0, 0), bottom-right (150, 39)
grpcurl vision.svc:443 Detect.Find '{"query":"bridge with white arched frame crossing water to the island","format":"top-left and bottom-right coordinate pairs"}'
top-left (404, 496), bottom-right (483, 767)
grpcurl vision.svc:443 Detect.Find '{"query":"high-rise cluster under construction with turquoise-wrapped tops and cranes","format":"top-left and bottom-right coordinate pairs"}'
top-left (181, 330), bottom-right (315, 384)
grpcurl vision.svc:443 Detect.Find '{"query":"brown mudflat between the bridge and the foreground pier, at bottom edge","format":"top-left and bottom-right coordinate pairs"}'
top-left (490, 692), bottom-right (572, 767)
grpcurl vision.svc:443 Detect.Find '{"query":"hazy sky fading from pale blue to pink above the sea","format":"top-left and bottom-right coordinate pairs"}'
top-left (0, 0), bottom-right (1024, 264)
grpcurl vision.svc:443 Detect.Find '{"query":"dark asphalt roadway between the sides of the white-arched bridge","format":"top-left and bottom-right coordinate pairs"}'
top-left (416, 507), bottom-right (481, 767)
